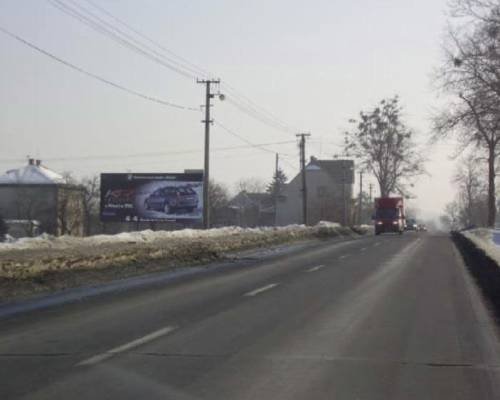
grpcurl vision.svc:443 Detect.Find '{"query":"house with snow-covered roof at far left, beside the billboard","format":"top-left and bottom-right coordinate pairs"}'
top-left (0, 159), bottom-right (85, 236)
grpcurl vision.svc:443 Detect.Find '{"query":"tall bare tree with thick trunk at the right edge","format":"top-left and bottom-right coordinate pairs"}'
top-left (434, 0), bottom-right (500, 226)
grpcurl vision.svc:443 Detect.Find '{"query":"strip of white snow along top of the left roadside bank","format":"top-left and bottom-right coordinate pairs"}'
top-left (0, 221), bottom-right (343, 252)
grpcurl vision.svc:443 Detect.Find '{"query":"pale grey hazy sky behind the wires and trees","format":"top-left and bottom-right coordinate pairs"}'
top-left (0, 0), bottom-right (454, 219)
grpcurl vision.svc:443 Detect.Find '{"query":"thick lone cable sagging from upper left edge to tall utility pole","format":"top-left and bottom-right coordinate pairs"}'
top-left (0, 26), bottom-right (199, 111)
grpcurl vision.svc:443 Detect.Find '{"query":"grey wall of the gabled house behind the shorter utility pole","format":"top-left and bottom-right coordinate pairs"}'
top-left (276, 169), bottom-right (353, 225)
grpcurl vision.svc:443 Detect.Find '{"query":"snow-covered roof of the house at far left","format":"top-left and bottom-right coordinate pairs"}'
top-left (0, 164), bottom-right (66, 185)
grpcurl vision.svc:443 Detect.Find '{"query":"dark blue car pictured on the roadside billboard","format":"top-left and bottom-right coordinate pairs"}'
top-left (144, 186), bottom-right (198, 214)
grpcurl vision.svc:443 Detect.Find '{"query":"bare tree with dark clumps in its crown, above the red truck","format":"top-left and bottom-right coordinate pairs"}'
top-left (344, 96), bottom-right (424, 197)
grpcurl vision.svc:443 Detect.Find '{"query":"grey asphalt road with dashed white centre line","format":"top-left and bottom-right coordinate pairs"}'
top-left (0, 234), bottom-right (500, 400)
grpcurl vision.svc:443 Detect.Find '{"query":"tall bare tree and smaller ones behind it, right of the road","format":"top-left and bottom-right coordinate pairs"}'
top-left (434, 0), bottom-right (500, 226)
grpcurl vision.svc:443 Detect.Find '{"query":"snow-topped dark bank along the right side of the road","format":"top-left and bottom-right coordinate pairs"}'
top-left (452, 228), bottom-right (500, 321)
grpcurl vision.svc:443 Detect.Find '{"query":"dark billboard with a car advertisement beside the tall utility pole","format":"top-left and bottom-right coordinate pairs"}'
top-left (100, 172), bottom-right (203, 222)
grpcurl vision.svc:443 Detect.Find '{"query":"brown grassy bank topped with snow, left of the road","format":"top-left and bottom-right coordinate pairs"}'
top-left (0, 222), bottom-right (370, 301)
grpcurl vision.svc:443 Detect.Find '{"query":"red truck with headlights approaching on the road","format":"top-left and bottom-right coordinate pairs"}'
top-left (373, 197), bottom-right (405, 235)
